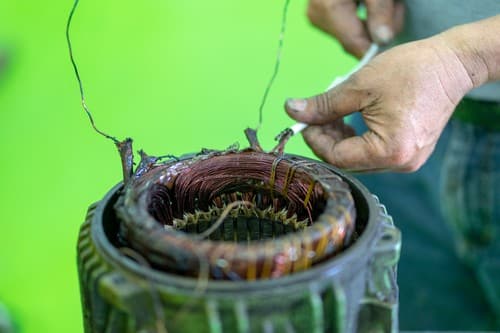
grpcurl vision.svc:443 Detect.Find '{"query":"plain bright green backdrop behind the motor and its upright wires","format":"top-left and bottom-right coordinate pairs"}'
top-left (0, 0), bottom-right (354, 332)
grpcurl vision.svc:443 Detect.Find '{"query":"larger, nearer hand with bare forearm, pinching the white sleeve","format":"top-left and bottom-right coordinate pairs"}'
top-left (285, 15), bottom-right (500, 172)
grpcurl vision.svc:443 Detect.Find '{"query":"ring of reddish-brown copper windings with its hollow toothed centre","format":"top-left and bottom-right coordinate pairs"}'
top-left (117, 149), bottom-right (356, 280)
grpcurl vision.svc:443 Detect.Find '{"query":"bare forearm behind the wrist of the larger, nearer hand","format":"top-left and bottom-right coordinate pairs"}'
top-left (435, 15), bottom-right (500, 90)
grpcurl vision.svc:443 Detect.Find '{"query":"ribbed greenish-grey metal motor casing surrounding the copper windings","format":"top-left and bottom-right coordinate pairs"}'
top-left (77, 160), bottom-right (401, 333)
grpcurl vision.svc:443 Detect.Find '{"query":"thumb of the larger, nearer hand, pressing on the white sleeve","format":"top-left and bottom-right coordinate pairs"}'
top-left (285, 81), bottom-right (361, 125)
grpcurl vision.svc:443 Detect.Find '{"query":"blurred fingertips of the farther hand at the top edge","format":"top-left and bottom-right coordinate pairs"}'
top-left (307, 0), bottom-right (404, 58)
